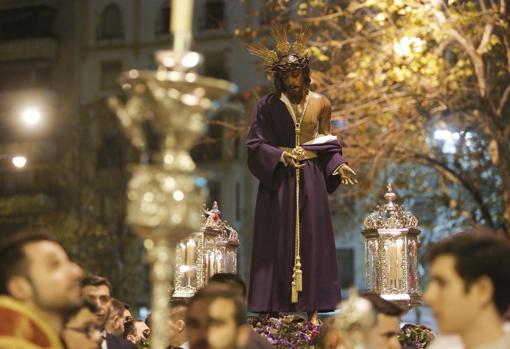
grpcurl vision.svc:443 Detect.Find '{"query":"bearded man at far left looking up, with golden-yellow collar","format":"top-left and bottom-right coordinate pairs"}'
top-left (0, 228), bottom-right (82, 349)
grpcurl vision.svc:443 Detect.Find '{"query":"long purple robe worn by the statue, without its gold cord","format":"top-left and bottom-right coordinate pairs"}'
top-left (246, 94), bottom-right (346, 312)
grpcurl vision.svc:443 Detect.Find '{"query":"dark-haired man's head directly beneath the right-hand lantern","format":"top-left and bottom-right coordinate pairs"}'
top-left (364, 294), bottom-right (402, 349)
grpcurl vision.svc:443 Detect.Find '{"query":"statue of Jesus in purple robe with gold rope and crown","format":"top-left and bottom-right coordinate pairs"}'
top-left (246, 26), bottom-right (357, 322)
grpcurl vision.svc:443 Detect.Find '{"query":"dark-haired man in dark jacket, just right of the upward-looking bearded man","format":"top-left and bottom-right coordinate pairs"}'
top-left (81, 275), bottom-right (134, 349)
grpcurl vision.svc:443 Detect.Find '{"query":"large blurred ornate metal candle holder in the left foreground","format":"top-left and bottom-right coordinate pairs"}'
top-left (109, 50), bottom-right (236, 349)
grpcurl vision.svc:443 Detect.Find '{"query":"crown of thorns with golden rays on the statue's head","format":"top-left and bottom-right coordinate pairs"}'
top-left (246, 25), bottom-right (312, 73)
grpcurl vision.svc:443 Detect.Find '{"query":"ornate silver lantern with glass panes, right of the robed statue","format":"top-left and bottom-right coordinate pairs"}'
top-left (361, 185), bottom-right (421, 308)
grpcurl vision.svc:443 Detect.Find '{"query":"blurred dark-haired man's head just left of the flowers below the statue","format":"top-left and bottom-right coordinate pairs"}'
top-left (186, 285), bottom-right (249, 349)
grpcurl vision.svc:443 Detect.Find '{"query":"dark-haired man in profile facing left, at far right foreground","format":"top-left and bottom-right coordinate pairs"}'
top-left (424, 229), bottom-right (510, 349)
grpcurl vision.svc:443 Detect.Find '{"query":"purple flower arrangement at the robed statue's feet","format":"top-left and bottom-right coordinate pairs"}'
top-left (248, 315), bottom-right (320, 349)
